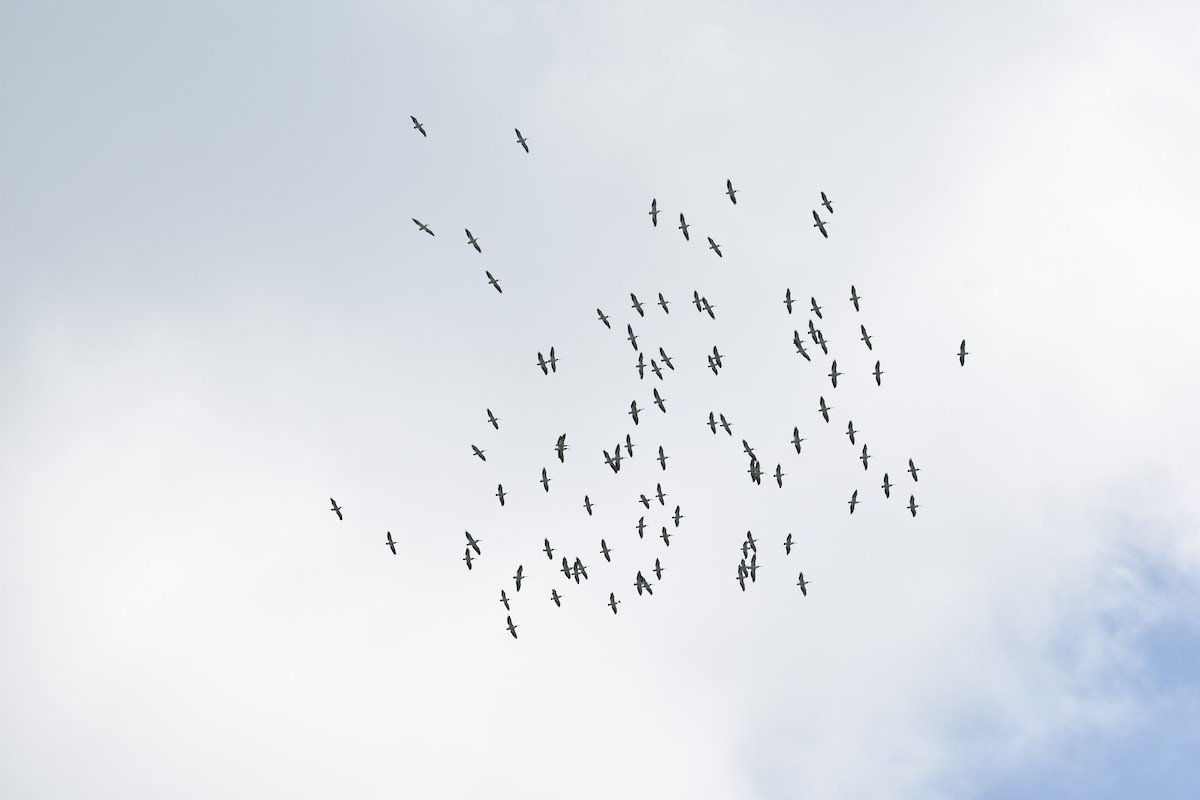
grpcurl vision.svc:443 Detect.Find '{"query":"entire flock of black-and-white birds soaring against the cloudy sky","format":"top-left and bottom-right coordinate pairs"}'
top-left (330, 116), bottom-right (968, 638)
